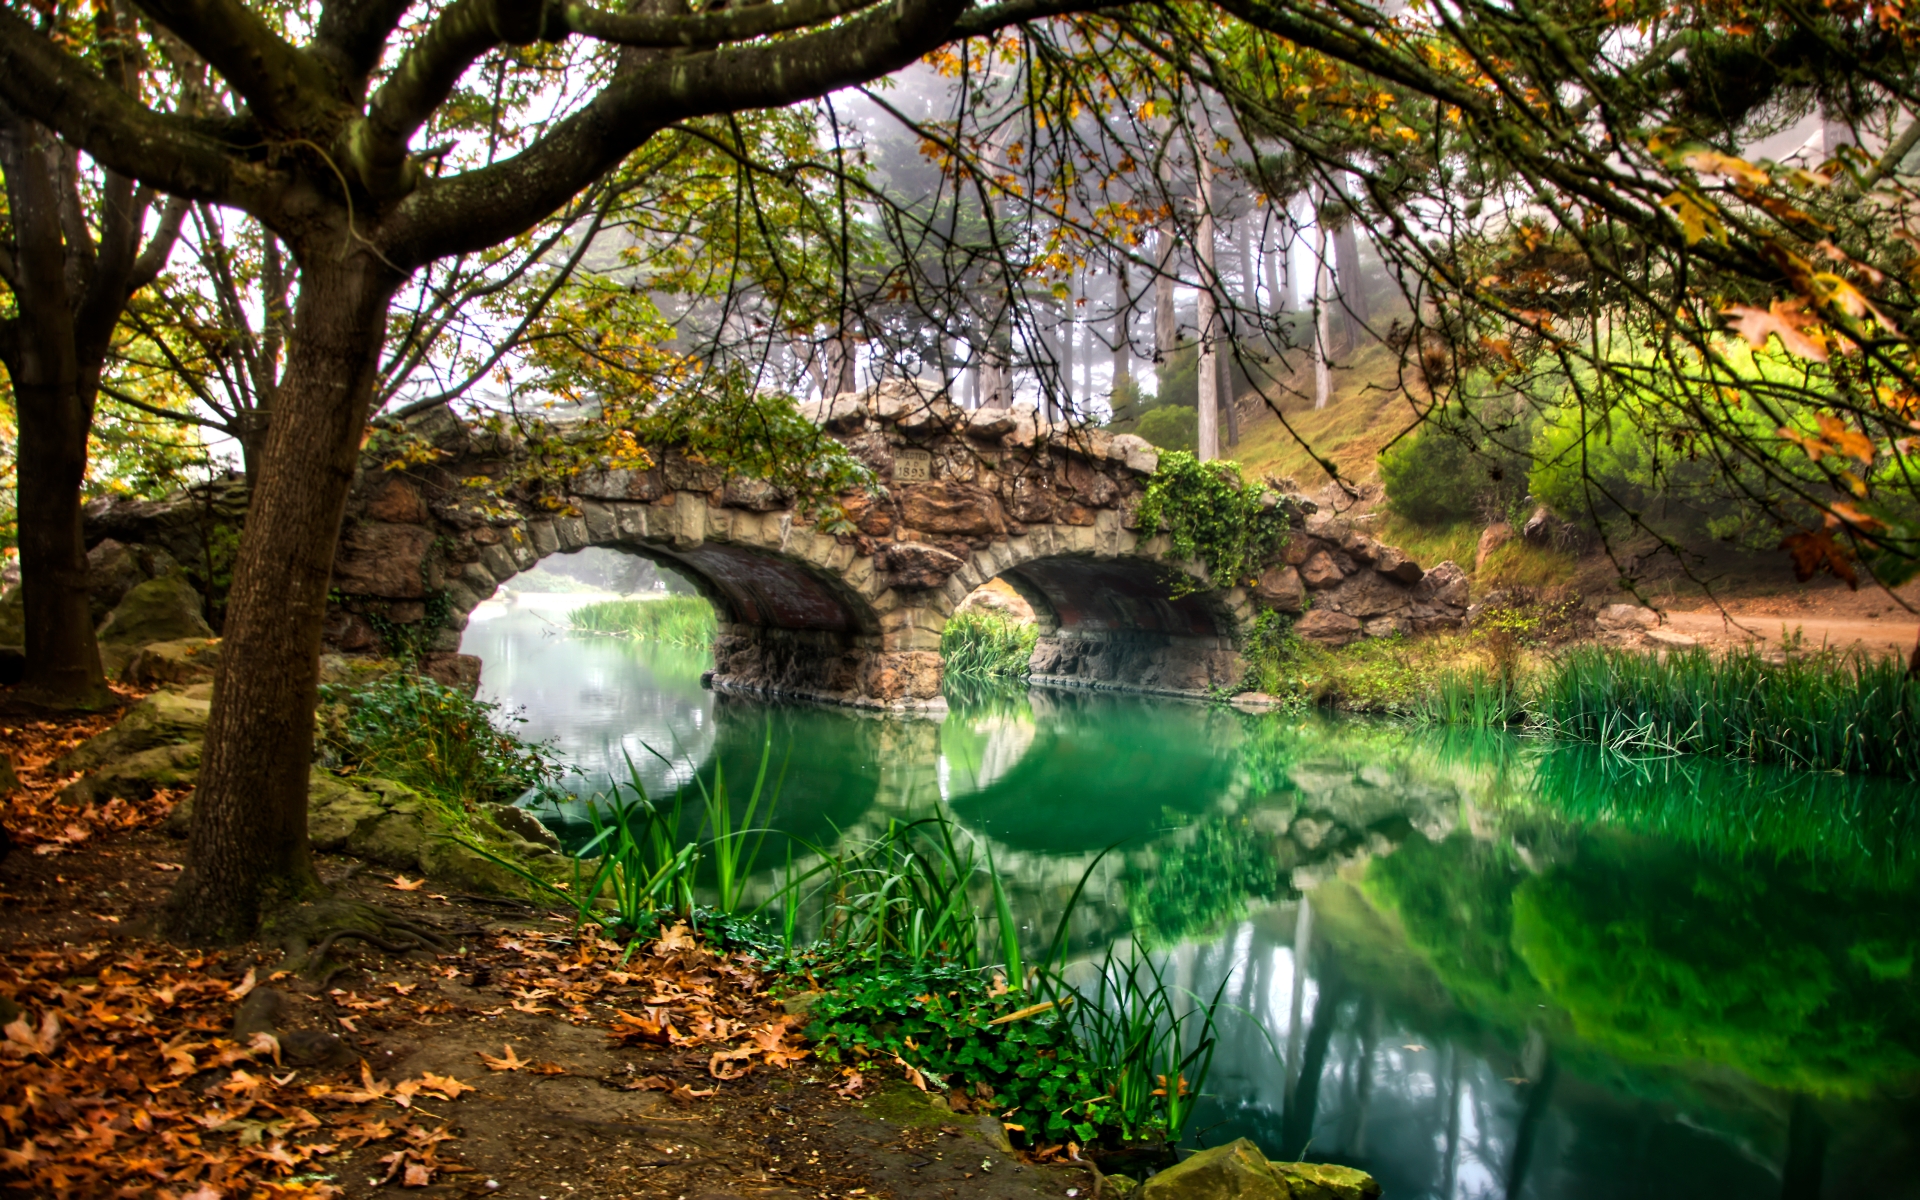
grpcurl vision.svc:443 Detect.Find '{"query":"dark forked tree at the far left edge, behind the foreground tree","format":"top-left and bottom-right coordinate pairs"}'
top-left (0, 4), bottom-right (190, 708)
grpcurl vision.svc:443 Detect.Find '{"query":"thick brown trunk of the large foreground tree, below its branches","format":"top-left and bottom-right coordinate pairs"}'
top-left (167, 250), bottom-right (403, 939)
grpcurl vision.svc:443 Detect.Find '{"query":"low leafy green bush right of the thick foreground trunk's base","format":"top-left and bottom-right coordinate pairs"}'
top-left (319, 672), bottom-right (561, 818)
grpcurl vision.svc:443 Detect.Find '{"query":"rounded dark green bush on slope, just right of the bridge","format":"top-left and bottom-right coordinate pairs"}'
top-left (1380, 417), bottom-right (1532, 526)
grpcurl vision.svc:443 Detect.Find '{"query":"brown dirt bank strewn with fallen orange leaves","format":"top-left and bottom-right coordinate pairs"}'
top-left (0, 706), bottom-right (1096, 1200)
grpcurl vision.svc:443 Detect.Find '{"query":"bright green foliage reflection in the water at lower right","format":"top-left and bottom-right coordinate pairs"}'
top-left (1365, 833), bottom-right (1920, 1094)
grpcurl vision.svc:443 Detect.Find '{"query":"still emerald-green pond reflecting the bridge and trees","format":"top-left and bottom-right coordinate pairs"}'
top-left (465, 605), bottom-right (1920, 1200)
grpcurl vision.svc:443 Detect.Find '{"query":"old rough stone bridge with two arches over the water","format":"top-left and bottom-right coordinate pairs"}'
top-left (326, 382), bottom-right (1466, 708)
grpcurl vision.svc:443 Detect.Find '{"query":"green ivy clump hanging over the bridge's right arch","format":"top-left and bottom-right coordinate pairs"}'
top-left (1140, 451), bottom-right (1292, 595)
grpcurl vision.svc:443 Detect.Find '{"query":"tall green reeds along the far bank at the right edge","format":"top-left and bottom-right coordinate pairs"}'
top-left (1528, 647), bottom-right (1920, 780)
